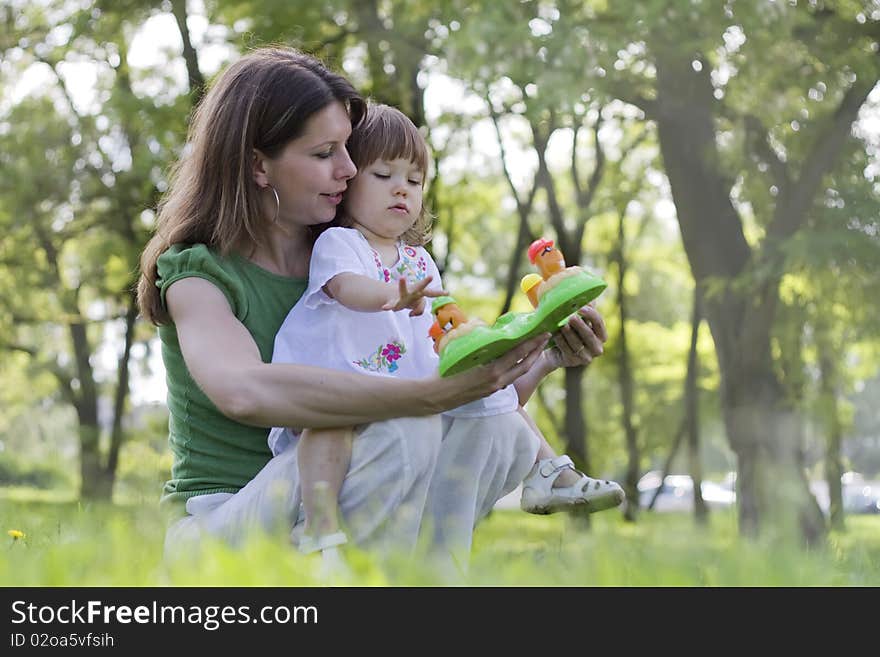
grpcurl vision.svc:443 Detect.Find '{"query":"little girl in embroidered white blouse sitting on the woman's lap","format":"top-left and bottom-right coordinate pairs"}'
top-left (269, 105), bottom-right (623, 557)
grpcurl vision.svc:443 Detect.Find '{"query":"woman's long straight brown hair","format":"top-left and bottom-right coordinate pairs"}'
top-left (138, 47), bottom-right (365, 324)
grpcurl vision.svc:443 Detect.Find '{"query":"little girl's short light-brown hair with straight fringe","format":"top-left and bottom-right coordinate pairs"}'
top-left (333, 103), bottom-right (433, 246)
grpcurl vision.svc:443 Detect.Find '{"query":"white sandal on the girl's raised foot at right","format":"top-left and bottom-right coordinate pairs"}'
top-left (519, 454), bottom-right (624, 515)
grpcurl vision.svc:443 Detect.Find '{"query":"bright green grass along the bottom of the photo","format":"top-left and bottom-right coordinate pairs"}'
top-left (0, 491), bottom-right (880, 587)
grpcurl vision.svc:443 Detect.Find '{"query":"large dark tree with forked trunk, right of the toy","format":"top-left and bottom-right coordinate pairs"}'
top-left (560, 2), bottom-right (880, 542)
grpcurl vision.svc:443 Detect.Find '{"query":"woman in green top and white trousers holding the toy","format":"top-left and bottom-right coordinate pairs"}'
top-left (138, 48), bottom-right (605, 551)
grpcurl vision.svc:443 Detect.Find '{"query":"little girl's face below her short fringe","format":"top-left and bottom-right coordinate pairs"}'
top-left (345, 158), bottom-right (424, 242)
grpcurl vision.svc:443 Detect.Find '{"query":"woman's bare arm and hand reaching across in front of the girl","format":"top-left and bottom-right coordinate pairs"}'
top-left (165, 278), bottom-right (548, 428)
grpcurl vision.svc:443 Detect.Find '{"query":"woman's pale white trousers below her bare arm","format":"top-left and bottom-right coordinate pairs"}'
top-left (165, 412), bottom-right (538, 556)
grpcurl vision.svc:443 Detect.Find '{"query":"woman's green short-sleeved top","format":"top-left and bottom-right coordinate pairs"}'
top-left (156, 244), bottom-right (308, 510)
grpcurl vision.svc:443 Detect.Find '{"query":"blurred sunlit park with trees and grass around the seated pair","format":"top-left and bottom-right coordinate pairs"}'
top-left (0, 0), bottom-right (880, 585)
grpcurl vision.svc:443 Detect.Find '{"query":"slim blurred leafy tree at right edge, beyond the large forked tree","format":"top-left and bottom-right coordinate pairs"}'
top-left (775, 144), bottom-right (880, 530)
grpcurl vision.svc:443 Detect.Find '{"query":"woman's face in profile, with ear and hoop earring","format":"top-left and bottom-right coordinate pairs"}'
top-left (254, 102), bottom-right (357, 226)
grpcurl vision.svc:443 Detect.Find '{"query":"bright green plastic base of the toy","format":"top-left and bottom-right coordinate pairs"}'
top-left (440, 271), bottom-right (608, 376)
